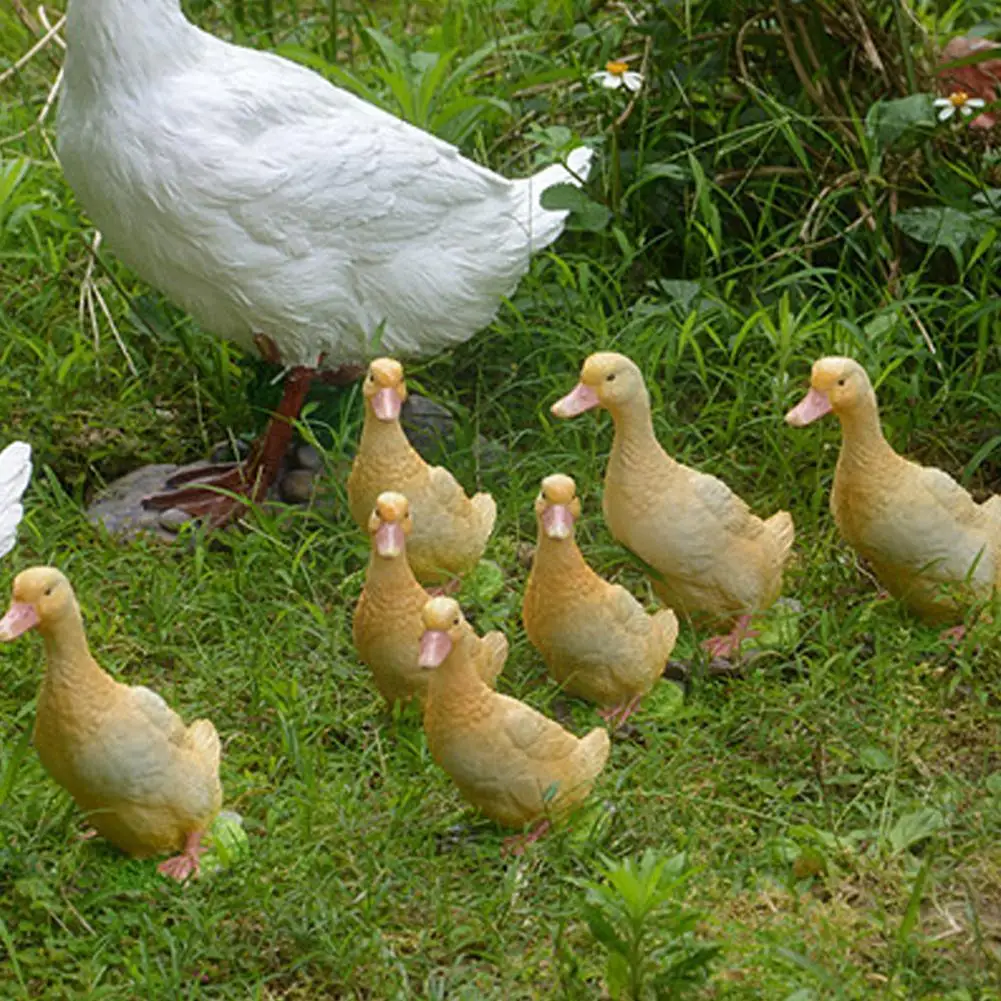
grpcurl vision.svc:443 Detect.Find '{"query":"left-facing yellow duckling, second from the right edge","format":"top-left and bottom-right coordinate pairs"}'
top-left (552, 351), bottom-right (795, 657)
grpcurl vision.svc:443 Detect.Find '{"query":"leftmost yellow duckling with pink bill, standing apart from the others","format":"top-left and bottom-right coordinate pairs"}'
top-left (0, 567), bottom-right (222, 881)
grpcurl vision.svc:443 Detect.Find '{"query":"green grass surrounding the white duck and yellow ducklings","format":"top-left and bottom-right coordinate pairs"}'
top-left (0, 0), bottom-right (1001, 1001)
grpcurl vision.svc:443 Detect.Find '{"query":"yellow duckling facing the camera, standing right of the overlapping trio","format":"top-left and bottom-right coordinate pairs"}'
top-left (522, 473), bottom-right (678, 725)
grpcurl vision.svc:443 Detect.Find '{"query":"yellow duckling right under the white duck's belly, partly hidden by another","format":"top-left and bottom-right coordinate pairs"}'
top-left (347, 358), bottom-right (496, 584)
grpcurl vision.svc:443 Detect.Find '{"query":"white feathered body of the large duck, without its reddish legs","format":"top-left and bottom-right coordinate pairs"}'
top-left (58, 0), bottom-right (591, 367)
